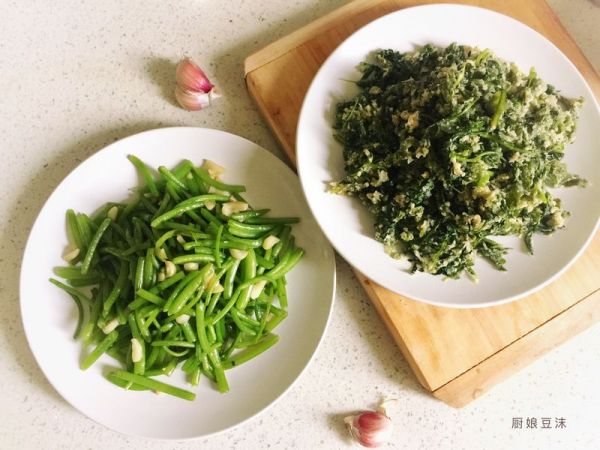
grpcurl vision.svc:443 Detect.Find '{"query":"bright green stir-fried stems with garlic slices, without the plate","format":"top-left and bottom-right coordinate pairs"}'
top-left (50, 155), bottom-right (304, 400)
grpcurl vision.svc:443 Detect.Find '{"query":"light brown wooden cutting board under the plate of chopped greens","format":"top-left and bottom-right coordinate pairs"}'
top-left (245, 0), bottom-right (600, 407)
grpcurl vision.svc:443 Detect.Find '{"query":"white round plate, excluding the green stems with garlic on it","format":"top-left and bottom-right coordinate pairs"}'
top-left (21, 128), bottom-right (335, 439)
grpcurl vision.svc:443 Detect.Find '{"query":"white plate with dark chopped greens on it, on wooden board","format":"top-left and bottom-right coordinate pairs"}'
top-left (296, 5), bottom-right (600, 307)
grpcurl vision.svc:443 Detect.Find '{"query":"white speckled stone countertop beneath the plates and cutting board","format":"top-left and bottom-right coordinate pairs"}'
top-left (0, 0), bottom-right (600, 450)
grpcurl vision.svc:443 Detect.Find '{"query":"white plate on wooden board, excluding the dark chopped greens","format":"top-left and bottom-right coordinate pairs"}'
top-left (296, 4), bottom-right (600, 307)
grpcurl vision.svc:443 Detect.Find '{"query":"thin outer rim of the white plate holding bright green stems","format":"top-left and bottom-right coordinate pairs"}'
top-left (19, 126), bottom-right (337, 442)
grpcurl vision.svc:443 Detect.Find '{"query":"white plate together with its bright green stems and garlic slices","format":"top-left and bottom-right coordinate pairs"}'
top-left (21, 128), bottom-right (335, 439)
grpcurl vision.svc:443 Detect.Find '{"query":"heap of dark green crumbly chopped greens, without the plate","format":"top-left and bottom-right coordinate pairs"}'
top-left (330, 44), bottom-right (585, 278)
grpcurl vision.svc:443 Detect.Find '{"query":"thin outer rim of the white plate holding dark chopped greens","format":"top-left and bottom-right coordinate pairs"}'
top-left (295, 3), bottom-right (600, 309)
